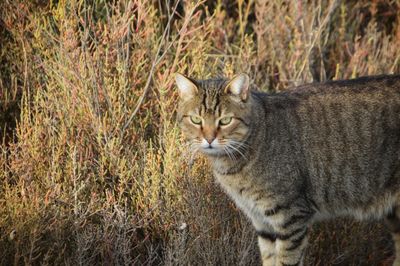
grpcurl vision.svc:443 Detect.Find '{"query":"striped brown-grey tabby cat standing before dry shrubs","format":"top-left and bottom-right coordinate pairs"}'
top-left (175, 73), bottom-right (400, 266)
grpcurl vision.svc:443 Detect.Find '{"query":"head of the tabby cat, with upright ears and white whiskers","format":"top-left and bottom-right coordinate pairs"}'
top-left (175, 74), bottom-right (251, 158)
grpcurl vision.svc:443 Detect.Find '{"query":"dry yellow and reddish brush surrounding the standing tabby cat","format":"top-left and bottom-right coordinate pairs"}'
top-left (0, 0), bottom-right (400, 265)
